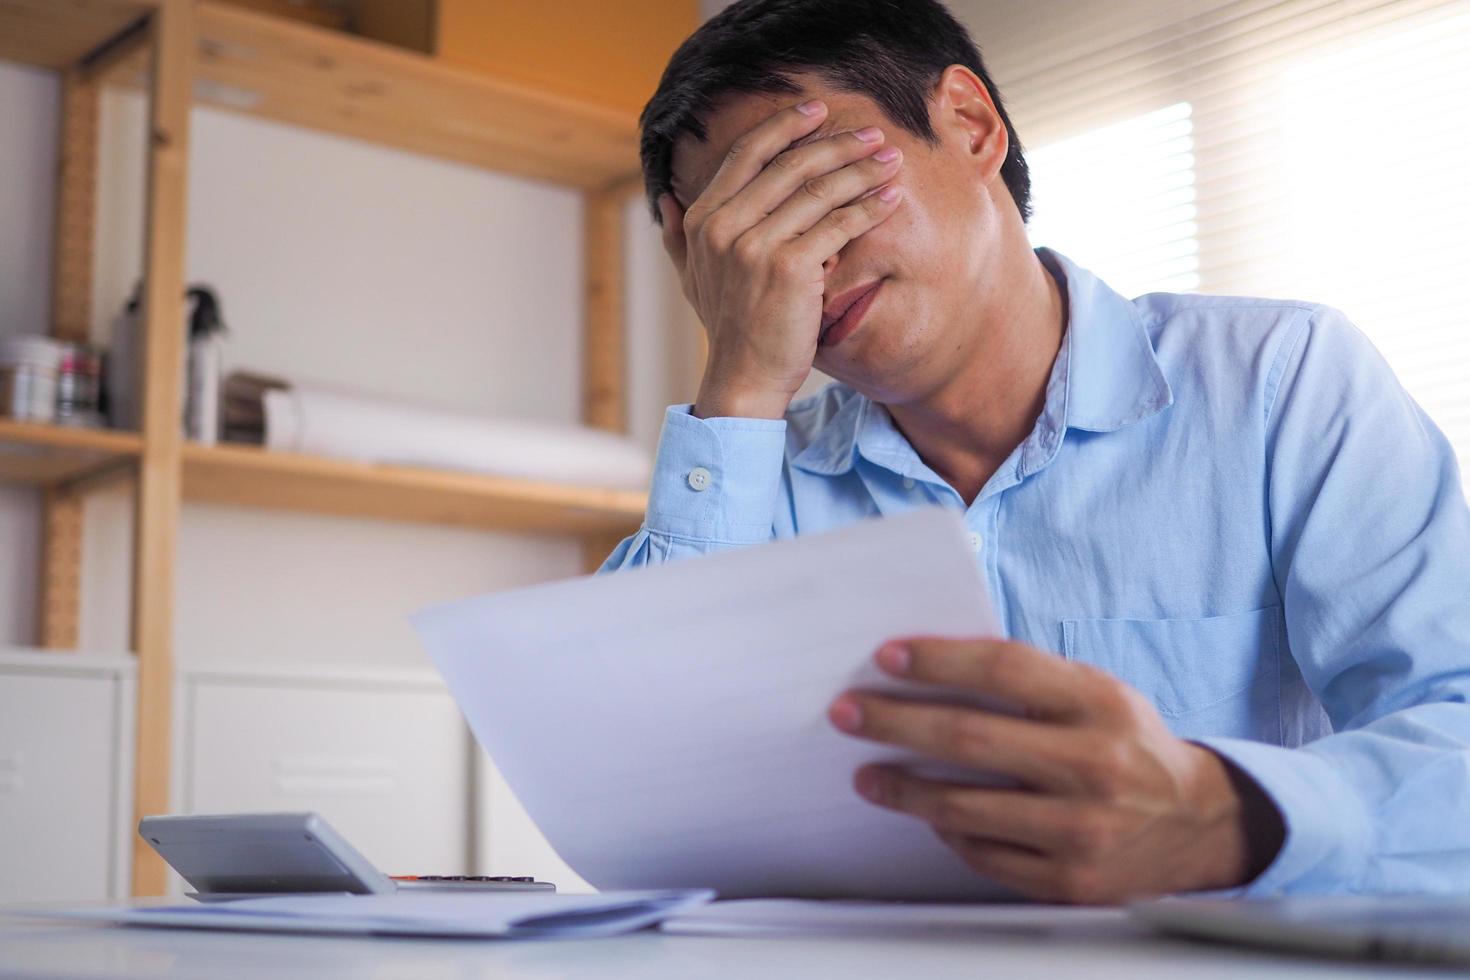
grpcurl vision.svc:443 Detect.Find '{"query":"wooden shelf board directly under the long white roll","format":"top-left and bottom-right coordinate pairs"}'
top-left (184, 445), bottom-right (647, 535)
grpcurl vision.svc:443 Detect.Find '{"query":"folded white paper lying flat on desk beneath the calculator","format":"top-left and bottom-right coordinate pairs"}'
top-left (16, 890), bottom-right (711, 939)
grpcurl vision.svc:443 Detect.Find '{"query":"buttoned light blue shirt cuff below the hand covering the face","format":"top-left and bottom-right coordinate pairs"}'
top-left (644, 406), bottom-right (786, 544)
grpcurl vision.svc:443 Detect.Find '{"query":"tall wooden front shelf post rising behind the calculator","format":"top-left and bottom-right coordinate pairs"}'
top-left (132, 0), bottom-right (196, 895)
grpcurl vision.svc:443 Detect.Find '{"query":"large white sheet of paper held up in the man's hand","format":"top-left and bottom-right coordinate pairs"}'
top-left (415, 508), bottom-right (1001, 901)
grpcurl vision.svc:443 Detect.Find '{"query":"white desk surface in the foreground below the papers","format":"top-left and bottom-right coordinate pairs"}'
top-left (0, 914), bottom-right (1422, 980)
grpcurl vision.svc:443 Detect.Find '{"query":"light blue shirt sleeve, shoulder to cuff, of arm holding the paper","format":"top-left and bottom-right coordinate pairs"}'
top-left (1202, 309), bottom-right (1470, 893)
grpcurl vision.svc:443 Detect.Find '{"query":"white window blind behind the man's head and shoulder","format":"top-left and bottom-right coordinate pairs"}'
top-left (954, 0), bottom-right (1470, 464)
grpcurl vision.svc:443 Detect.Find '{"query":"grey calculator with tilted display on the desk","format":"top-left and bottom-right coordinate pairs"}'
top-left (138, 813), bottom-right (556, 902)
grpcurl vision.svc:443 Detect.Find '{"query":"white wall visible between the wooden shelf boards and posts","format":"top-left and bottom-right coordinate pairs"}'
top-left (0, 63), bottom-right (697, 666)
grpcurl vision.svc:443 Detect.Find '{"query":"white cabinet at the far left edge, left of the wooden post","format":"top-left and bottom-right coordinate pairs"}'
top-left (0, 651), bottom-right (134, 902)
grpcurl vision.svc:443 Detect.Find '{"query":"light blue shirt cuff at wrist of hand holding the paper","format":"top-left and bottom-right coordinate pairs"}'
top-left (1198, 738), bottom-right (1372, 898)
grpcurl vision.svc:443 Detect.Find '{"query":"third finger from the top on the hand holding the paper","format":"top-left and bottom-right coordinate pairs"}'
top-left (854, 765), bottom-right (1079, 854)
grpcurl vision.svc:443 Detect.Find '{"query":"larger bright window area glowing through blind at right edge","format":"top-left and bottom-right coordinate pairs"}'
top-left (1282, 8), bottom-right (1470, 464)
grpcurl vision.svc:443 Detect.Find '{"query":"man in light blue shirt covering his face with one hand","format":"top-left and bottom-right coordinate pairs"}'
top-left (604, 0), bottom-right (1470, 902)
